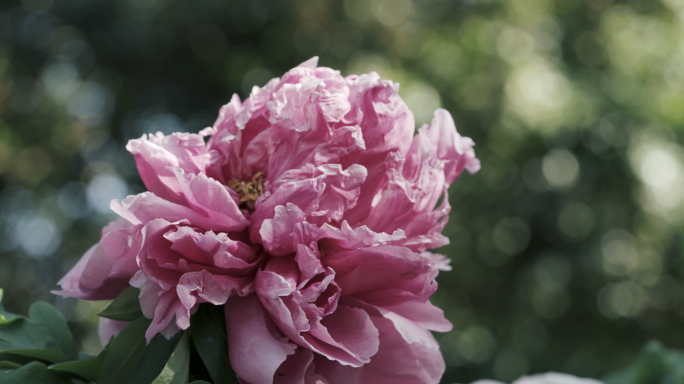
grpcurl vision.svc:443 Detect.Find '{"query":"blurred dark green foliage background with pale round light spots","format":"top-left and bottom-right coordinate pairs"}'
top-left (0, 0), bottom-right (684, 383)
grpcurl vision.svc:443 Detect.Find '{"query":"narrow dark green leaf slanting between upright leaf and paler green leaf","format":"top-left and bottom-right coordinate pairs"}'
top-left (127, 332), bottom-right (182, 384)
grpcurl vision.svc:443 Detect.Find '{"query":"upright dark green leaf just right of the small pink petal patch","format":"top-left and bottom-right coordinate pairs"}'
top-left (98, 317), bottom-right (151, 384)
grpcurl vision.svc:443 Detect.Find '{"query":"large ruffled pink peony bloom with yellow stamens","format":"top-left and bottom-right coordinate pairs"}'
top-left (53, 58), bottom-right (480, 384)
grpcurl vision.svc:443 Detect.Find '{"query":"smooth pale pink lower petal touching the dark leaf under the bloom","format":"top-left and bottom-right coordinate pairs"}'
top-left (225, 295), bottom-right (296, 384)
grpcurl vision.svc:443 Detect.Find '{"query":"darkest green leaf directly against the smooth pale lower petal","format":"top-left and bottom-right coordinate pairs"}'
top-left (190, 304), bottom-right (238, 384)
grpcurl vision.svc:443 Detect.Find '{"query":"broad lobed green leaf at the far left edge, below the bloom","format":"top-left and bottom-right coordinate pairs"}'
top-left (0, 302), bottom-right (77, 363)
